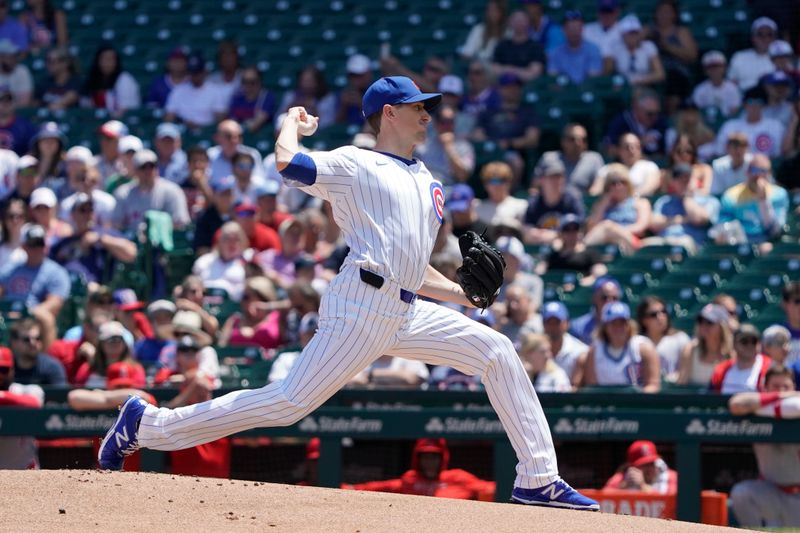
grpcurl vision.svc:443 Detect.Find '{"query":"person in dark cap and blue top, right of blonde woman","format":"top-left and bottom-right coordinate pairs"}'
top-left (642, 163), bottom-right (720, 250)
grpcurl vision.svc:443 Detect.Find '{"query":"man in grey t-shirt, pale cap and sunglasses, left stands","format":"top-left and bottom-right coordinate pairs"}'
top-left (112, 150), bottom-right (189, 232)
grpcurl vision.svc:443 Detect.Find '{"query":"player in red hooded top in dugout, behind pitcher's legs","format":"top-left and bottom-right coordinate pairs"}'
top-left (343, 439), bottom-right (496, 500)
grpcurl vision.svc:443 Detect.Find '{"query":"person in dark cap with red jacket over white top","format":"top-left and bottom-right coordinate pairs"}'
top-left (709, 324), bottom-right (772, 394)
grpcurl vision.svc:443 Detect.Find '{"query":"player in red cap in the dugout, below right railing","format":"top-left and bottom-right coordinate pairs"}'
top-left (603, 440), bottom-right (678, 494)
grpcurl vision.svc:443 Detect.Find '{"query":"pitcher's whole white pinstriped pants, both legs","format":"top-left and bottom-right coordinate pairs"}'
top-left (138, 270), bottom-right (558, 488)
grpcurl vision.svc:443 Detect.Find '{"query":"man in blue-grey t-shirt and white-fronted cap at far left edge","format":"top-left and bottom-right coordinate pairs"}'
top-left (0, 224), bottom-right (72, 346)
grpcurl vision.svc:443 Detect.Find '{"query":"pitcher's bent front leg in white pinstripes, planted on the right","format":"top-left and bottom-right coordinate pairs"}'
top-left (387, 301), bottom-right (558, 489)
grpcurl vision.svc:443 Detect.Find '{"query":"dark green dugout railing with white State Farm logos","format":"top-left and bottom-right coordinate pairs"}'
top-left (0, 390), bottom-right (800, 521)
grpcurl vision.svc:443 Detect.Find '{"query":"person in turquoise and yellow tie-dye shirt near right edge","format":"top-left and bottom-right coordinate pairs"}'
top-left (719, 154), bottom-right (789, 243)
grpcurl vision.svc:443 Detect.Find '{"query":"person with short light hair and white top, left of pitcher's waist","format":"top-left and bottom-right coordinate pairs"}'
top-left (192, 222), bottom-right (249, 301)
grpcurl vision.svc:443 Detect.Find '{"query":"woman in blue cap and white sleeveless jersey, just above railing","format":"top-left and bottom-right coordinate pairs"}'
top-left (575, 302), bottom-right (661, 393)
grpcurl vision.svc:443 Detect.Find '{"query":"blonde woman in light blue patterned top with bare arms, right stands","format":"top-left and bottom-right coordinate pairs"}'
top-left (583, 163), bottom-right (652, 254)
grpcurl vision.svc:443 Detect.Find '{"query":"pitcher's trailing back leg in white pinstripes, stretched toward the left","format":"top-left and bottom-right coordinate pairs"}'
top-left (138, 317), bottom-right (396, 450)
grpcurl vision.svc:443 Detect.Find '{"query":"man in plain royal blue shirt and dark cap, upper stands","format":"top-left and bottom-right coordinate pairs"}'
top-left (547, 10), bottom-right (603, 85)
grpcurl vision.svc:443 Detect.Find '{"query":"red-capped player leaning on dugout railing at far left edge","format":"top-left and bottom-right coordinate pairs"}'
top-left (0, 346), bottom-right (44, 470)
